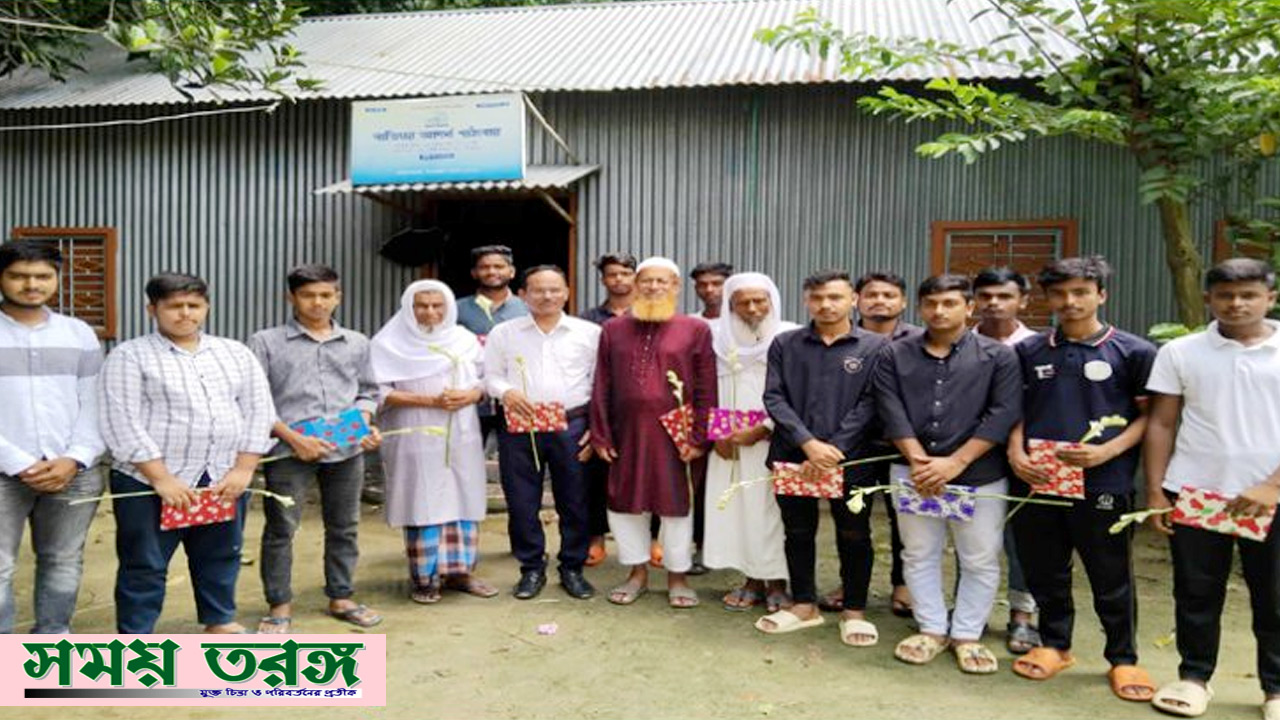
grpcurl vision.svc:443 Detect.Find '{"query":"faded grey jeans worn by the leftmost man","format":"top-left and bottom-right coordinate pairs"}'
top-left (0, 468), bottom-right (102, 633)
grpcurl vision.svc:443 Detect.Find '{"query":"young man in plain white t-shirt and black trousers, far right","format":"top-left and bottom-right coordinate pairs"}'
top-left (1143, 258), bottom-right (1280, 720)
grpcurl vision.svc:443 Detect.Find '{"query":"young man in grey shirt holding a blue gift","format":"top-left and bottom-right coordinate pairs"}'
top-left (248, 265), bottom-right (383, 633)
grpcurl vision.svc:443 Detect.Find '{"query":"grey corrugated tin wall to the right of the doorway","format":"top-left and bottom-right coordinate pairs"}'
top-left (535, 87), bottom-right (1211, 329)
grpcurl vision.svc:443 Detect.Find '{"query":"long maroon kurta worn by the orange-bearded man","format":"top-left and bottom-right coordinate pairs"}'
top-left (591, 315), bottom-right (716, 518)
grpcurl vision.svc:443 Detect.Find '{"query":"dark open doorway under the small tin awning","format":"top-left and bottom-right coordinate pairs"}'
top-left (420, 196), bottom-right (575, 311)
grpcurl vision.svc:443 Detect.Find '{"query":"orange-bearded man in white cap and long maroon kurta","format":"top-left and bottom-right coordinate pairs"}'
top-left (591, 258), bottom-right (716, 607)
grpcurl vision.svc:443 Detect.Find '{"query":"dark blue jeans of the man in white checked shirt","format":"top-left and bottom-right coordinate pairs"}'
top-left (111, 470), bottom-right (248, 634)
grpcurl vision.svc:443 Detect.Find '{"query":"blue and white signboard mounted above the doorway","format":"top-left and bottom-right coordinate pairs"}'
top-left (351, 92), bottom-right (525, 184)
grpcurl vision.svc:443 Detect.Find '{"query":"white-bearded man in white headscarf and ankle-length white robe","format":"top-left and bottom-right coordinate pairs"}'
top-left (703, 273), bottom-right (797, 612)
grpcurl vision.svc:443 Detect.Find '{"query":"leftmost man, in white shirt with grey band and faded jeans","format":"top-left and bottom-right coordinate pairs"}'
top-left (0, 241), bottom-right (102, 633)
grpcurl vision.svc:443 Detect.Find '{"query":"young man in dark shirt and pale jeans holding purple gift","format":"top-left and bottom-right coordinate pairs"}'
top-left (876, 275), bottom-right (1021, 674)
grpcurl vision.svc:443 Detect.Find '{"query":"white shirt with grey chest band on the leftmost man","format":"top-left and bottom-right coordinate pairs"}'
top-left (0, 311), bottom-right (104, 475)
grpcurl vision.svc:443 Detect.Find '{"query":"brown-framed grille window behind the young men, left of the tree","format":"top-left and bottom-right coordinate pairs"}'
top-left (932, 219), bottom-right (1079, 328)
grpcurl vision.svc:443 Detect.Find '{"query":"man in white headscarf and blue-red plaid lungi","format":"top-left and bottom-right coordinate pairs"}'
top-left (370, 281), bottom-right (498, 603)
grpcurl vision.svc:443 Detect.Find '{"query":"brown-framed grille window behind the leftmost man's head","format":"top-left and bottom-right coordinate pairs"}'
top-left (10, 227), bottom-right (115, 340)
